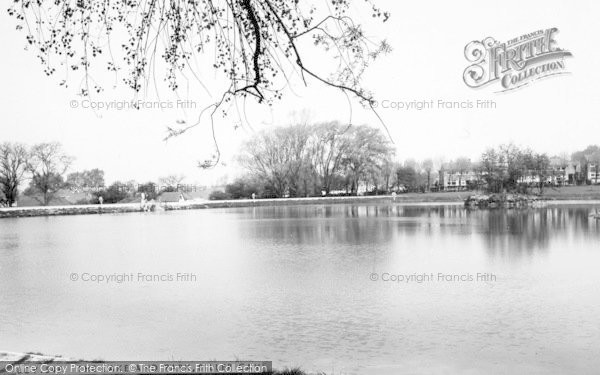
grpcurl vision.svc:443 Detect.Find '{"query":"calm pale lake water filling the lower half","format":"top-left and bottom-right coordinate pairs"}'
top-left (0, 205), bottom-right (600, 374)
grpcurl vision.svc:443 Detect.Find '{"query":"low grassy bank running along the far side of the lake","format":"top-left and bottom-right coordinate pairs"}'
top-left (0, 185), bottom-right (600, 219)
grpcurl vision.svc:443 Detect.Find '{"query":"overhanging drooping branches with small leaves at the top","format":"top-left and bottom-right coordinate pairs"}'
top-left (9, 0), bottom-right (390, 162)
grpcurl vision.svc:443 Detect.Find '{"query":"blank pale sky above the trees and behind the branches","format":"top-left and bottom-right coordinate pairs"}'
top-left (0, 0), bottom-right (600, 184)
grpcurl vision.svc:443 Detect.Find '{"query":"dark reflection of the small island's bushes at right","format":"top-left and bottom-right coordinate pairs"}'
top-left (470, 206), bottom-right (600, 255)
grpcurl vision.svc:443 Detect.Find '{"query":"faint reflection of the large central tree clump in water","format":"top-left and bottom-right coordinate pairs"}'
top-left (243, 205), bottom-right (467, 245)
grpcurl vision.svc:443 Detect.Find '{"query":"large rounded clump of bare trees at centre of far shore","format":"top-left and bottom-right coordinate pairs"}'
top-left (213, 122), bottom-right (394, 199)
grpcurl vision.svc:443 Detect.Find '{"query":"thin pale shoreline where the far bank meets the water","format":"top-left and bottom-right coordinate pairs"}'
top-left (0, 192), bottom-right (600, 219)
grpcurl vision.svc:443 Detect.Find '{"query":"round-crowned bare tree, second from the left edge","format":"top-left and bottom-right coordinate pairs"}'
top-left (27, 142), bottom-right (73, 206)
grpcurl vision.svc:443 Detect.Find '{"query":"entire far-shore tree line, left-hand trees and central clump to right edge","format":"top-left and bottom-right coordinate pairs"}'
top-left (0, 134), bottom-right (600, 207)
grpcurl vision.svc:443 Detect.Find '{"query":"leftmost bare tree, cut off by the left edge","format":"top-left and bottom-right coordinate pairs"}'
top-left (0, 142), bottom-right (28, 207)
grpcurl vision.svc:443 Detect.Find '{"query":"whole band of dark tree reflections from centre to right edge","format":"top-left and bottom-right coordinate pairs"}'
top-left (239, 205), bottom-right (600, 253)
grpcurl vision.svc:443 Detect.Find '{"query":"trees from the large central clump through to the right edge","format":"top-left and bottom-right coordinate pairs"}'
top-left (217, 122), bottom-right (600, 199)
